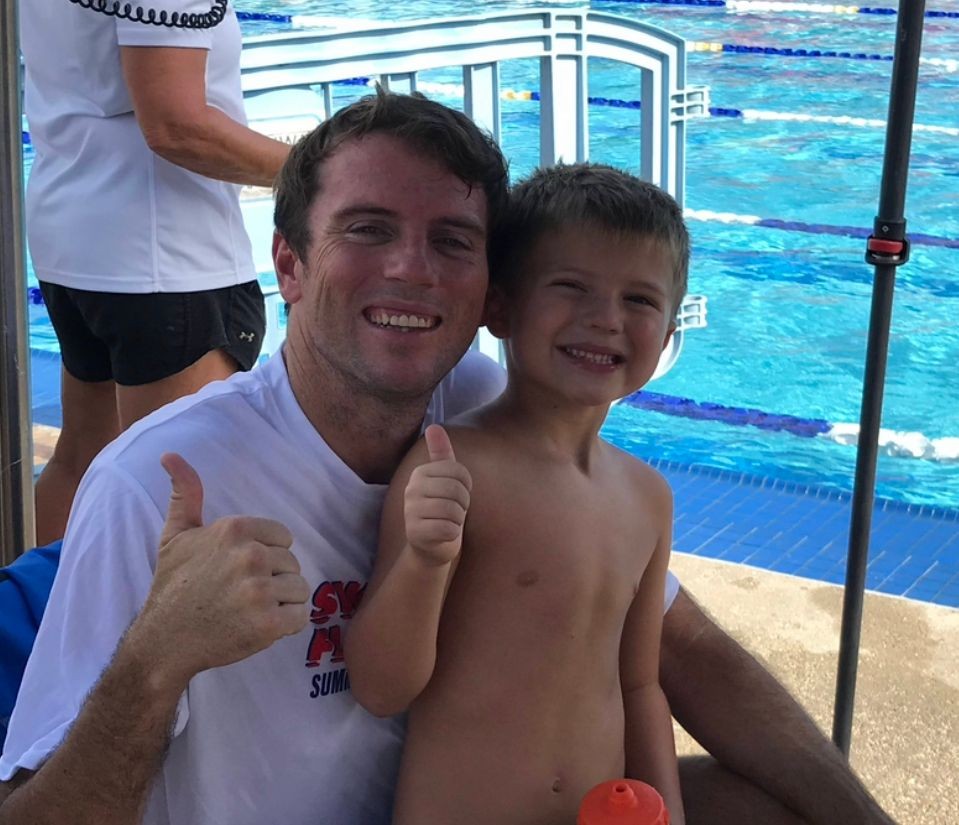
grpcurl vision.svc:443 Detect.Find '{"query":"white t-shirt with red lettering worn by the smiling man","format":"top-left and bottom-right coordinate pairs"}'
top-left (0, 353), bottom-right (678, 825)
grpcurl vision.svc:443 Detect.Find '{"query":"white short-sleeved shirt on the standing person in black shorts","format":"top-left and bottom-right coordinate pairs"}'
top-left (20, 0), bottom-right (256, 293)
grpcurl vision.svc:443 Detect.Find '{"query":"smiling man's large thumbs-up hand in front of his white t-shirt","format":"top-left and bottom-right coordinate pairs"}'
top-left (129, 453), bottom-right (310, 690)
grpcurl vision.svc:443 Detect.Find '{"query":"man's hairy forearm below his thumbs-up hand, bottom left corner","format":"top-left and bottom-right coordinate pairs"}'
top-left (0, 638), bottom-right (181, 825)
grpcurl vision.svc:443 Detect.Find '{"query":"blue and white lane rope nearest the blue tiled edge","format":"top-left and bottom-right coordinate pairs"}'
top-left (621, 390), bottom-right (959, 463)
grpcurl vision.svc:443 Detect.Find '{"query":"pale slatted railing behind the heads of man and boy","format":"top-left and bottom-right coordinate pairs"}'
top-left (241, 9), bottom-right (709, 376)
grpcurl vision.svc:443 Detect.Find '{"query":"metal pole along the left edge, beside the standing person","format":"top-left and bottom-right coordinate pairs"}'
top-left (0, 0), bottom-right (35, 564)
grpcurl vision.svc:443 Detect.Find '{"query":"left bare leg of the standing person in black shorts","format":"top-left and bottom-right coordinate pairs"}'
top-left (34, 368), bottom-right (120, 545)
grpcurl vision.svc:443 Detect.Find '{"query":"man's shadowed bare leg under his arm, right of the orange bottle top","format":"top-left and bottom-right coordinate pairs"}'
top-left (679, 756), bottom-right (815, 825)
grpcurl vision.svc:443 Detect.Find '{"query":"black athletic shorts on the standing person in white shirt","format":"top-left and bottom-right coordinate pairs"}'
top-left (40, 281), bottom-right (266, 386)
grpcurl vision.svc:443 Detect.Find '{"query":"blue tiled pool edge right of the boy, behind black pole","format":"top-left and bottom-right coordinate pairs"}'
top-left (650, 460), bottom-right (959, 607)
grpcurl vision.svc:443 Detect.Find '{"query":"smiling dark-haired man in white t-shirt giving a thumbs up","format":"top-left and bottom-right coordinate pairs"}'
top-left (0, 93), bottom-right (889, 825)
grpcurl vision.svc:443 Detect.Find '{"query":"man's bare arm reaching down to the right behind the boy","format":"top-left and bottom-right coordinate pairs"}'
top-left (660, 591), bottom-right (893, 825)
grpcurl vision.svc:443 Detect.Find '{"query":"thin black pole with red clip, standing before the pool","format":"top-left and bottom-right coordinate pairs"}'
top-left (832, 0), bottom-right (925, 756)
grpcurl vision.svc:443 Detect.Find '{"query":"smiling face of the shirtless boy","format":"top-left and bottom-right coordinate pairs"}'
top-left (493, 227), bottom-right (675, 406)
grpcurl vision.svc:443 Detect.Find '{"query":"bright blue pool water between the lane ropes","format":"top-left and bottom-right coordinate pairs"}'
top-left (22, 0), bottom-right (959, 507)
